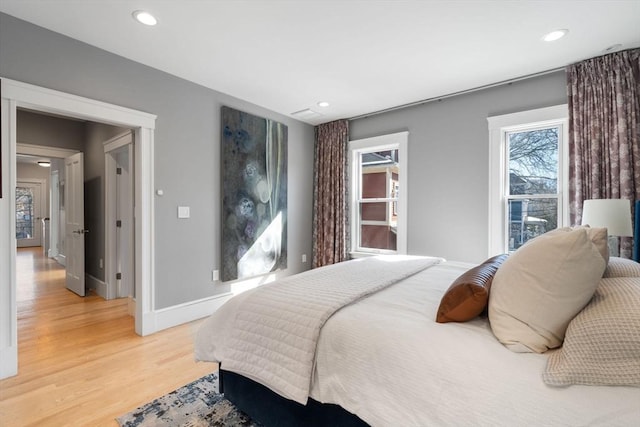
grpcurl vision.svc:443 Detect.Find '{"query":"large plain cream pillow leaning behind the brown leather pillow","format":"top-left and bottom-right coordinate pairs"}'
top-left (489, 228), bottom-right (606, 353)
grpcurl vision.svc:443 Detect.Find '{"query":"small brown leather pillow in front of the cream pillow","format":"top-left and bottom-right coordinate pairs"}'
top-left (436, 254), bottom-right (507, 323)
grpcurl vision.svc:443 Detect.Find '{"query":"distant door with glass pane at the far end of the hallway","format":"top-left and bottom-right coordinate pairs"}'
top-left (16, 181), bottom-right (44, 248)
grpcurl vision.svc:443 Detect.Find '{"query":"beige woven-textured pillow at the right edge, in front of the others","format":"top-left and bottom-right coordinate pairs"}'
top-left (542, 278), bottom-right (640, 388)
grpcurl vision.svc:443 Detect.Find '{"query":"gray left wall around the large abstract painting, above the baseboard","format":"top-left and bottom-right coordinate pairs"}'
top-left (0, 14), bottom-right (314, 308)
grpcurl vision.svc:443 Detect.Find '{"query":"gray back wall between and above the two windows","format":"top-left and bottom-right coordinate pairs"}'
top-left (350, 71), bottom-right (567, 262)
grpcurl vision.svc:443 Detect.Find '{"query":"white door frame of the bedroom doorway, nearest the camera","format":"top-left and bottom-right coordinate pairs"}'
top-left (0, 78), bottom-right (156, 378)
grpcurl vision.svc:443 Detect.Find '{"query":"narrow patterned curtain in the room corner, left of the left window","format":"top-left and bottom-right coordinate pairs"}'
top-left (312, 120), bottom-right (349, 268)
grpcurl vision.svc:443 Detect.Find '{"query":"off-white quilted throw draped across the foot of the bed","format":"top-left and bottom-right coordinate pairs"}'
top-left (210, 256), bottom-right (442, 405)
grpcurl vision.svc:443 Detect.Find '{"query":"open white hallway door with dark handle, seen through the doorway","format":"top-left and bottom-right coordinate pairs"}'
top-left (64, 153), bottom-right (87, 296)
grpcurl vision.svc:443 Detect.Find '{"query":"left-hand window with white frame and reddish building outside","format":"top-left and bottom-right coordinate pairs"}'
top-left (349, 132), bottom-right (408, 256)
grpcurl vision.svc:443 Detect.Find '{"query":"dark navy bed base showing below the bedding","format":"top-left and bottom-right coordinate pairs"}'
top-left (220, 369), bottom-right (368, 427)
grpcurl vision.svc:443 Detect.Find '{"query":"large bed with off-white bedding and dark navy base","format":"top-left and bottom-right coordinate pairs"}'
top-left (196, 230), bottom-right (640, 426)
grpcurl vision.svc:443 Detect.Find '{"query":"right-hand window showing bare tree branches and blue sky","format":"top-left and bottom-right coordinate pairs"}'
top-left (489, 105), bottom-right (569, 255)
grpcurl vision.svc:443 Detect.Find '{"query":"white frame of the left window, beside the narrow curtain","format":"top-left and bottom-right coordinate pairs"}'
top-left (349, 131), bottom-right (409, 258)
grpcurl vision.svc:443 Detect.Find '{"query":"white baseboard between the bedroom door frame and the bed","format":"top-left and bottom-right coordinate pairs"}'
top-left (149, 292), bottom-right (233, 333)
